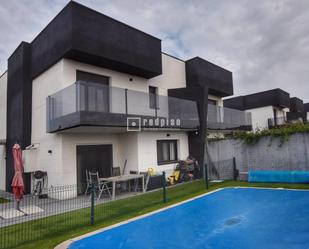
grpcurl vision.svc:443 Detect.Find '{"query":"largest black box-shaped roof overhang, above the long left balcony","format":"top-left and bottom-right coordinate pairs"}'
top-left (32, 2), bottom-right (162, 78)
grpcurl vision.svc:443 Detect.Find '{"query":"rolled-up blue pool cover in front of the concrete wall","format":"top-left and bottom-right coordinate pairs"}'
top-left (248, 170), bottom-right (309, 183)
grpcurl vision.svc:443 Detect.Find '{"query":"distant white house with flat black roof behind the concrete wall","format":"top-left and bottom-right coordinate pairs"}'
top-left (224, 88), bottom-right (303, 131)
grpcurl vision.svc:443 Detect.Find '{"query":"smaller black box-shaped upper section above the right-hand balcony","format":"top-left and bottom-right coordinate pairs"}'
top-left (186, 57), bottom-right (233, 97)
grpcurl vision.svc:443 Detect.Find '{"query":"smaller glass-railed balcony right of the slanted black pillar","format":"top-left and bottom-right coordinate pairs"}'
top-left (207, 104), bottom-right (252, 131)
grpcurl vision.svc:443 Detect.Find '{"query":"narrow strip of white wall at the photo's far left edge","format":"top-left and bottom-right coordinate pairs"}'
top-left (0, 72), bottom-right (7, 140)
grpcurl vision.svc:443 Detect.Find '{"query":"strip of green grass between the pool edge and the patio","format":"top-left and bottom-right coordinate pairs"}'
top-left (0, 181), bottom-right (309, 249)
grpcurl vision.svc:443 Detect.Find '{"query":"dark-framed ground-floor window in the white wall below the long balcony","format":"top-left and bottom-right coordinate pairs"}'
top-left (157, 140), bottom-right (178, 165)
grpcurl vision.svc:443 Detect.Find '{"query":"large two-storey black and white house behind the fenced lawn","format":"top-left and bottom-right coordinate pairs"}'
top-left (0, 1), bottom-right (245, 190)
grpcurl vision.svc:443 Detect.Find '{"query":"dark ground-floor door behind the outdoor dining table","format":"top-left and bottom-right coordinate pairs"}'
top-left (77, 144), bottom-right (113, 194)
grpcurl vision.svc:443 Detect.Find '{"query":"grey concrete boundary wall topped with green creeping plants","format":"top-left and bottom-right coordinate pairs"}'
top-left (208, 133), bottom-right (309, 178)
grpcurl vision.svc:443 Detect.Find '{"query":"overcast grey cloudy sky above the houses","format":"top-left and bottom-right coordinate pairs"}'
top-left (0, 0), bottom-right (309, 102)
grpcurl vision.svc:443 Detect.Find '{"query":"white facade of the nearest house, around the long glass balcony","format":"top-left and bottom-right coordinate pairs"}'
top-left (25, 54), bottom-right (188, 186)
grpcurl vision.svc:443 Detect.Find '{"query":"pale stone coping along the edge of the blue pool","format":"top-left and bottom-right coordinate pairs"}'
top-left (54, 186), bottom-right (309, 249)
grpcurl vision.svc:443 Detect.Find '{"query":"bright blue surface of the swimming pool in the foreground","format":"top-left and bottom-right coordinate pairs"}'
top-left (69, 188), bottom-right (309, 249)
